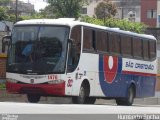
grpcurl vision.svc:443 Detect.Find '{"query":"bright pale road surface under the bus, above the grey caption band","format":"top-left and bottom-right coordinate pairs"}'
top-left (0, 102), bottom-right (160, 114)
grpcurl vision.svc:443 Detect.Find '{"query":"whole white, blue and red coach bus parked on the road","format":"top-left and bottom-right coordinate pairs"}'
top-left (3, 18), bottom-right (157, 106)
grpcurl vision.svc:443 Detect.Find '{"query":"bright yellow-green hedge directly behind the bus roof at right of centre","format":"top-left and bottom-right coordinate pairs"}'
top-left (81, 16), bottom-right (147, 33)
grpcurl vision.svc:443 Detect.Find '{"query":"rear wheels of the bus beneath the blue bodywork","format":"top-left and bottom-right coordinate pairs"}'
top-left (116, 86), bottom-right (135, 106)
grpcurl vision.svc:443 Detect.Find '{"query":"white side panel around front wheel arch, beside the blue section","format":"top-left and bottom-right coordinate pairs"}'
top-left (72, 53), bottom-right (98, 96)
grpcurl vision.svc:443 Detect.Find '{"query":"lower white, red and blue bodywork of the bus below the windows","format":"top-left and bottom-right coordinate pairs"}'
top-left (7, 53), bottom-right (157, 97)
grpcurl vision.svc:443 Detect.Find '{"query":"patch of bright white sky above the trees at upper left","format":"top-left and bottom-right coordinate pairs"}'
top-left (20, 0), bottom-right (48, 11)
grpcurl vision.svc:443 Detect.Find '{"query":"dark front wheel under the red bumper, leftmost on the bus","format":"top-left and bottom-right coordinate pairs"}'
top-left (27, 94), bottom-right (41, 103)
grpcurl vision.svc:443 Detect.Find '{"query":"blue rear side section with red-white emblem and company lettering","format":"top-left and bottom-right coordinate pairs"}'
top-left (99, 55), bottom-right (157, 97)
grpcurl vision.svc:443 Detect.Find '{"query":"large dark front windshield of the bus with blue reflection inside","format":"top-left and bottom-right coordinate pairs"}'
top-left (7, 25), bottom-right (69, 74)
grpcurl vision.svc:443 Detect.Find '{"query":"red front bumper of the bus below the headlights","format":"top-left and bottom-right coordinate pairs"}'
top-left (6, 81), bottom-right (65, 96)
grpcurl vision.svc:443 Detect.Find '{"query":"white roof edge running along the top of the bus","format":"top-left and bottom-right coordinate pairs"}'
top-left (15, 18), bottom-right (156, 40)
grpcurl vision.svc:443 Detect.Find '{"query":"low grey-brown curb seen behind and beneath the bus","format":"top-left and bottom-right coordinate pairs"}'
top-left (0, 90), bottom-right (160, 105)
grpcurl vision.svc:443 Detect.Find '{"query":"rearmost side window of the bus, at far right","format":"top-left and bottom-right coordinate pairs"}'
top-left (149, 41), bottom-right (156, 60)
